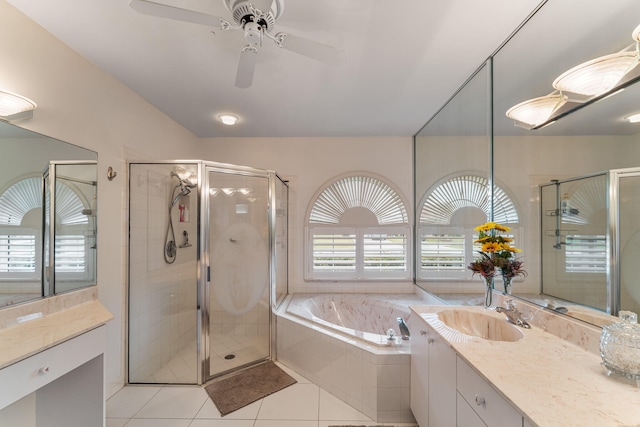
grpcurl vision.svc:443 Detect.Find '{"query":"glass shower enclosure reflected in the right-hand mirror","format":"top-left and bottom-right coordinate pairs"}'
top-left (540, 168), bottom-right (640, 315)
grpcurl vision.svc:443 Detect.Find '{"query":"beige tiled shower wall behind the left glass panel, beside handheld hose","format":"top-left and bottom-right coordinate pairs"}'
top-left (128, 165), bottom-right (197, 382)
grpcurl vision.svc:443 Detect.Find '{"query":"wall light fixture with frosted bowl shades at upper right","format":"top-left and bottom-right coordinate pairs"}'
top-left (506, 25), bottom-right (640, 130)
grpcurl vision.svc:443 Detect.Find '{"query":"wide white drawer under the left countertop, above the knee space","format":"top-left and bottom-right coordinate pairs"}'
top-left (0, 326), bottom-right (106, 409)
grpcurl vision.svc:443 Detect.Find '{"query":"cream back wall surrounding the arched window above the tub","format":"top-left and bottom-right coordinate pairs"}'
top-left (202, 137), bottom-right (413, 292)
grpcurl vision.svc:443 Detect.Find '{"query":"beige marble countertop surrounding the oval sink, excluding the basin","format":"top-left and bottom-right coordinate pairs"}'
top-left (411, 306), bottom-right (640, 427)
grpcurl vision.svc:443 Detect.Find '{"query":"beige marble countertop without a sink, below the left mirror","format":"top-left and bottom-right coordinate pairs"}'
top-left (0, 300), bottom-right (113, 369)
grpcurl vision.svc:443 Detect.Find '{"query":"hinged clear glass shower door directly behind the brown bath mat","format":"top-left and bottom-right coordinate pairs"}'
top-left (205, 167), bottom-right (271, 378)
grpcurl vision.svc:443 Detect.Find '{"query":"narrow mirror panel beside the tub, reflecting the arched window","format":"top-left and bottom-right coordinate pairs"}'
top-left (414, 65), bottom-right (491, 298)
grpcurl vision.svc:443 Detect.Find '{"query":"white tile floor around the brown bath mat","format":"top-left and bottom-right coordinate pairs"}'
top-left (106, 365), bottom-right (416, 427)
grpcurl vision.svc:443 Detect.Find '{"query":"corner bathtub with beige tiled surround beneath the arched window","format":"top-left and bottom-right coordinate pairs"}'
top-left (276, 293), bottom-right (442, 423)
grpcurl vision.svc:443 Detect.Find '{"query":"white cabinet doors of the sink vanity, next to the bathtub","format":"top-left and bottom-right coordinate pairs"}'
top-left (409, 316), bottom-right (456, 427)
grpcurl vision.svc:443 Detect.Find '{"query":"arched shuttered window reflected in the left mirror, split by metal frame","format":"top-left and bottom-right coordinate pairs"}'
top-left (0, 177), bottom-right (90, 281)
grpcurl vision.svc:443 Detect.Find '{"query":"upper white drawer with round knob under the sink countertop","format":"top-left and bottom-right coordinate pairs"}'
top-left (456, 357), bottom-right (522, 427)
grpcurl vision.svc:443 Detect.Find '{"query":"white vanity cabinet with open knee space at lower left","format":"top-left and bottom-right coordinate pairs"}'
top-left (0, 325), bottom-right (106, 427)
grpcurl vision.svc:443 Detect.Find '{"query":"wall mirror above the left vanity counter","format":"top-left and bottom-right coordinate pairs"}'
top-left (0, 121), bottom-right (98, 308)
